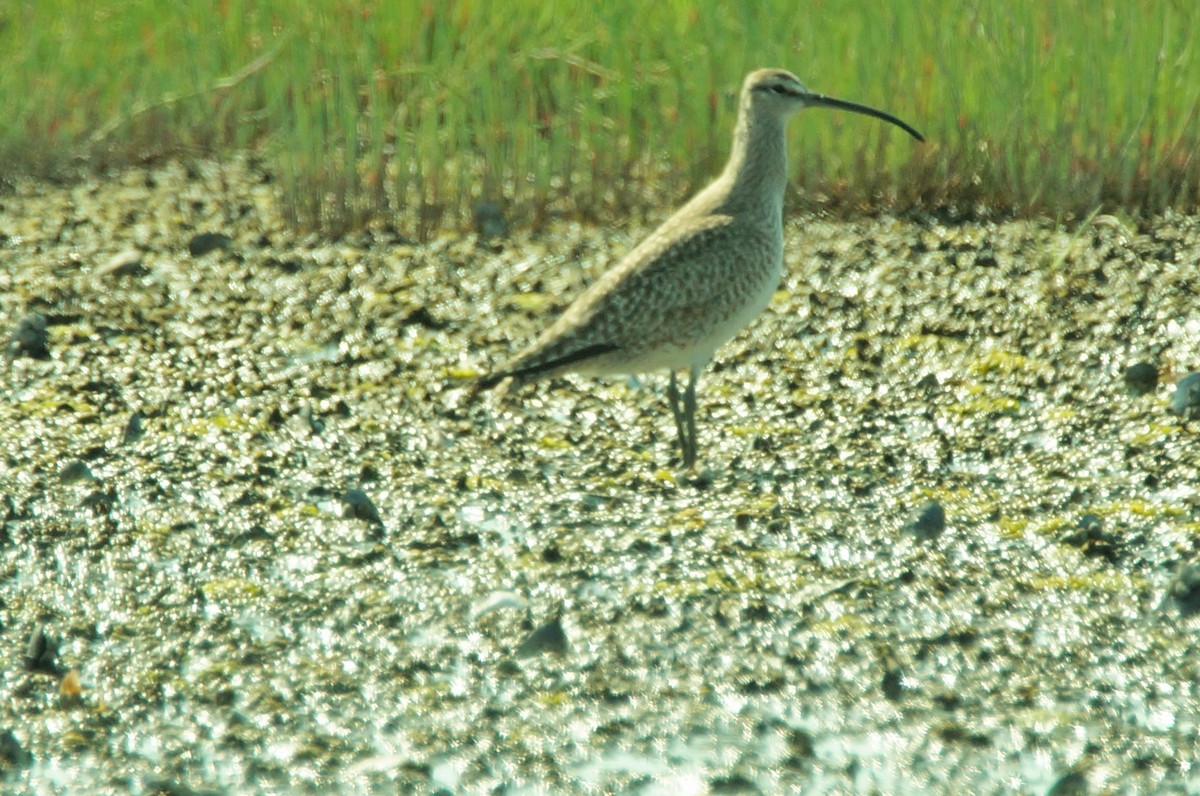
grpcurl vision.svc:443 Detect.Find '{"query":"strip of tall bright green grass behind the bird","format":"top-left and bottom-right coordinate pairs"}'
top-left (0, 0), bottom-right (1200, 233)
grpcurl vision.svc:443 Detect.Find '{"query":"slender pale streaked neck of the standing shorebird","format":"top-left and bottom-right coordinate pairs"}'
top-left (721, 107), bottom-right (787, 216)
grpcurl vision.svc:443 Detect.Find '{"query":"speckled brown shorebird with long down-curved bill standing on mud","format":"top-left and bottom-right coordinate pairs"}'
top-left (474, 70), bottom-right (924, 469)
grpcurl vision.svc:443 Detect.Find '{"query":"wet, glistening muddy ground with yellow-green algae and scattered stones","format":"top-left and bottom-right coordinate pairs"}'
top-left (0, 162), bottom-right (1200, 795)
